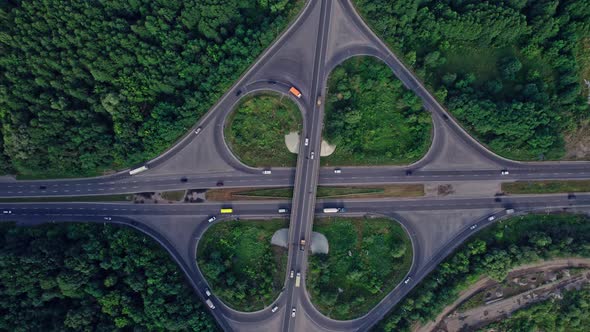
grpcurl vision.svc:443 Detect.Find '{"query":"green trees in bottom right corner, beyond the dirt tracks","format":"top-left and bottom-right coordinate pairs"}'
top-left (480, 286), bottom-right (590, 332)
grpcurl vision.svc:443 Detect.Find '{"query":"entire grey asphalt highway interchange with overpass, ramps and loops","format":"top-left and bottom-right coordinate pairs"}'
top-left (0, 0), bottom-right (590, 331)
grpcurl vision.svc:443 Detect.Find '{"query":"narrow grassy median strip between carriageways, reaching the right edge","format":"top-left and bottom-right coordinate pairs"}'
top-left (502, 180), bottom-right (590, 194)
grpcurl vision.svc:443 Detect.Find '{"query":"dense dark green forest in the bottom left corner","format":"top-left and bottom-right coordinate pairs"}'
top-left (0, 223), bottom-right (218, 332)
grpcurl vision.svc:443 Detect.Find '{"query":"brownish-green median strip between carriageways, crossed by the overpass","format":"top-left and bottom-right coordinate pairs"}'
top-left (206, 184), bottom-right (424, 201)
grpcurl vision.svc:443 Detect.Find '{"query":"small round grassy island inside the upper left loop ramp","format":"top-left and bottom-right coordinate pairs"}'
top-left (225, 93), bottom-right (302, 167)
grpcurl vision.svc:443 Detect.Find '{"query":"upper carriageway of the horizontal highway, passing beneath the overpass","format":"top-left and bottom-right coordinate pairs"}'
top-left (0, 169), bottom-right (590, 197)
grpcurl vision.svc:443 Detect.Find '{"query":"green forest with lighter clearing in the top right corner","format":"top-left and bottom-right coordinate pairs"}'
top-left (354, 0), bottom-right (590, 160)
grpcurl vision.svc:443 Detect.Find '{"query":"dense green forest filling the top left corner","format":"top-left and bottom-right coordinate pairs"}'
top-left (0, 0), bottom-right (303, 176)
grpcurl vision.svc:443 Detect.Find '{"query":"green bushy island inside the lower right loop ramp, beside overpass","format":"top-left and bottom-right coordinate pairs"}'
top-left (307, 218), bottom-right (412, 319)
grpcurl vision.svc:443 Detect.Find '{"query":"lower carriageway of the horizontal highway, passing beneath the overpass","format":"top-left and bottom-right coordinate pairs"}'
top-left (0, 193), bottom-right (590, 221)
